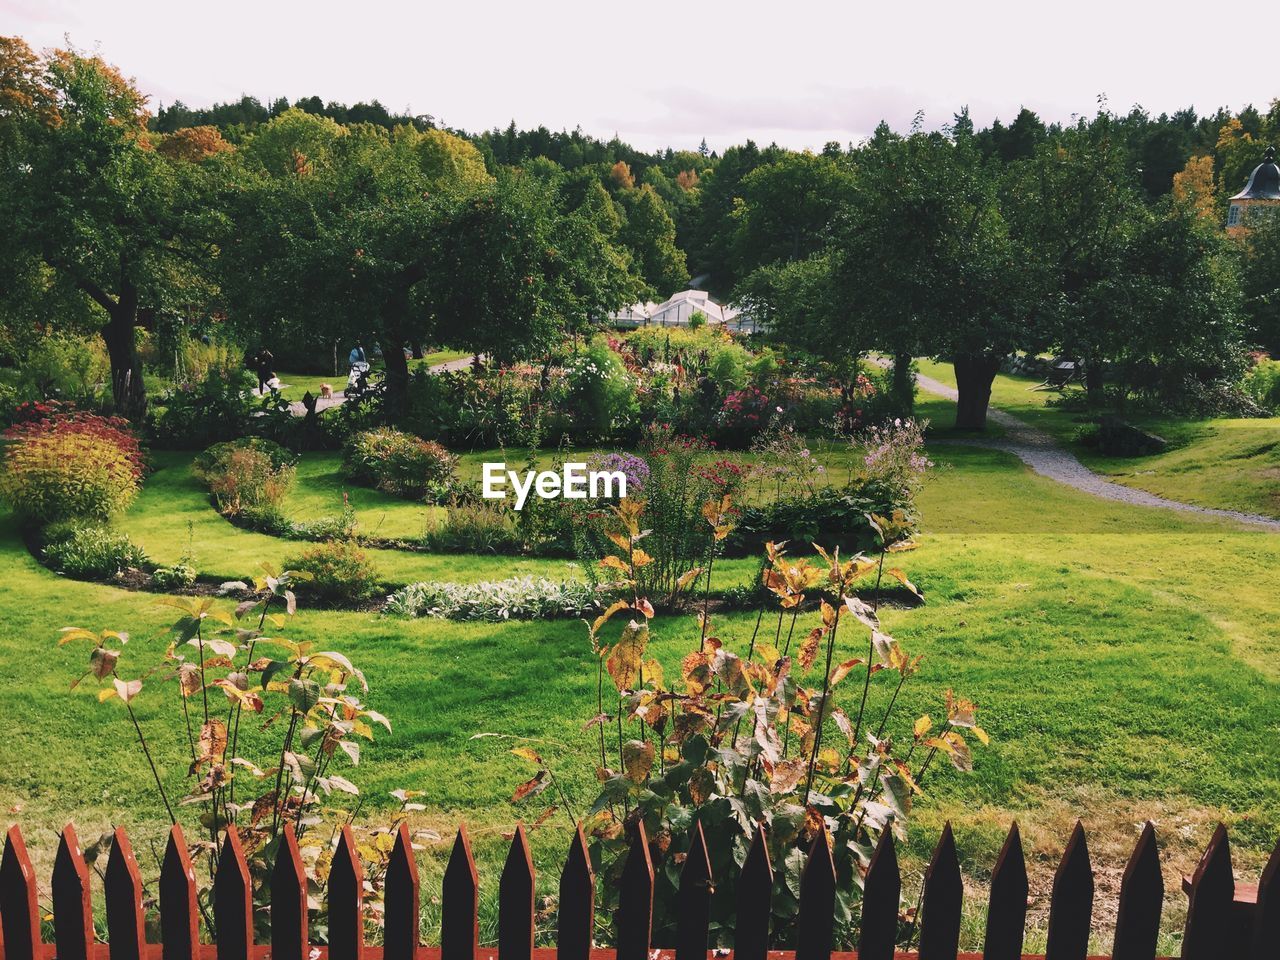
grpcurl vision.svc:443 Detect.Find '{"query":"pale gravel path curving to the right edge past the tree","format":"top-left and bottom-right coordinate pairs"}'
top-left (915, 375), bottom-right (1280, 532)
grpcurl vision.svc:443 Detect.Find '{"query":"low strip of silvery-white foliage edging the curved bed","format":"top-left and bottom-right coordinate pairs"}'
top-left (385, 576), bottom-right (600, 623)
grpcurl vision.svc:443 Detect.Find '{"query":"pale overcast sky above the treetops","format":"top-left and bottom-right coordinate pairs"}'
top-left (10, 0), bottom-right (1280, 150)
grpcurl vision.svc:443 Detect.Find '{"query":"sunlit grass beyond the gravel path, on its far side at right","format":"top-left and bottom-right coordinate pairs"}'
top-left (920, 361), bottom-right (1280, 517)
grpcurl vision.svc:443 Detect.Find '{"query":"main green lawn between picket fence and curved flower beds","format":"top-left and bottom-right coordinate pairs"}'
top-left (0, 435), bottom-right (1280, 947)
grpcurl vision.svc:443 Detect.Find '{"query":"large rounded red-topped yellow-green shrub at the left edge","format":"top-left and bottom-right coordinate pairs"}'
top-left (0, 403), bottom-right (142, 524)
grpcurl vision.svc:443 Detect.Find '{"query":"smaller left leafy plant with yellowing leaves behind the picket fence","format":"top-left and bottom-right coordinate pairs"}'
top-left (59, 570), bottom-right (399, 933)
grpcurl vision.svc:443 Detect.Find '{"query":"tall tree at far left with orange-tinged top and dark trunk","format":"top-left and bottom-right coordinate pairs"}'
top-left (0, 40), bottom-right (214, 417)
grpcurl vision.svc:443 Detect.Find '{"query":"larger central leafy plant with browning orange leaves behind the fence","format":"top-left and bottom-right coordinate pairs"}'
top-left (513, 500), bottom-right (987, 946)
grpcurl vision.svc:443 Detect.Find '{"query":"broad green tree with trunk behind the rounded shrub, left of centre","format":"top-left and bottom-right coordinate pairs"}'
top-left (221, 122), bottom-right (450, 417)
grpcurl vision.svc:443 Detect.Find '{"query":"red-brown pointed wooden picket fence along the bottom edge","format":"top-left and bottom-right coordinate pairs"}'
top-left (0, 823), bottom-right (1280, 960)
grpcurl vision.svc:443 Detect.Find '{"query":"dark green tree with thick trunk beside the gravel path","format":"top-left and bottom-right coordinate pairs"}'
top-left (833, 132), bottom-right (1037, 430)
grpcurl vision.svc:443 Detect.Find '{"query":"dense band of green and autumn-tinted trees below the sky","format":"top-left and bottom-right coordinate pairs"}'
top-left (0, 38), bottom-right (1280, 426)
